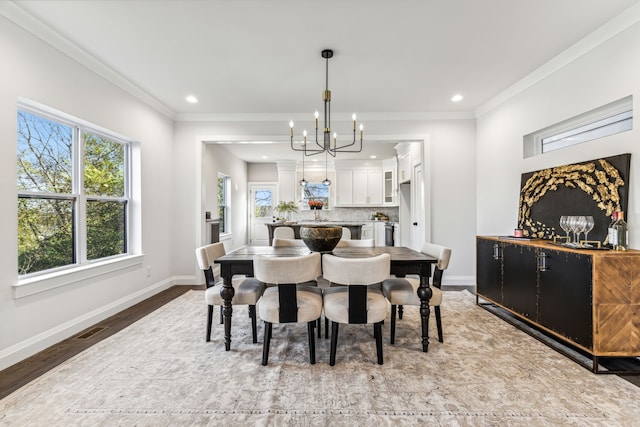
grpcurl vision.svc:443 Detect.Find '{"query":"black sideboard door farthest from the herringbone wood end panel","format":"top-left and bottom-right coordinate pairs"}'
top-left (476, 239), bottom-right (502, 304)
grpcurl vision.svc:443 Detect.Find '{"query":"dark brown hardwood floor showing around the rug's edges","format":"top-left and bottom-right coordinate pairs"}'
top-left (0, 286), bottom-right (640, 399)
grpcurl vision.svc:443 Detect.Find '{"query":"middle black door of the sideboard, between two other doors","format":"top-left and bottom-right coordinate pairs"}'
top-left (502, 243), bottom-right (538, 321)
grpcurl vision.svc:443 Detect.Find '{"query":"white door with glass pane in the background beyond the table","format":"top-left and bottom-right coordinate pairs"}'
top-left (249, 184), bottom-right (277, 246)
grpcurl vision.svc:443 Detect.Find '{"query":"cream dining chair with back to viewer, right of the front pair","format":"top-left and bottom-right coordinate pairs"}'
top-left (322, 254), bottom-right (391, 366)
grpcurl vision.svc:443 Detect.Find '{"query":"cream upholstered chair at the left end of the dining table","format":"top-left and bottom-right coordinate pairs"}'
top-left (196, 242), bottom-right (265, 343)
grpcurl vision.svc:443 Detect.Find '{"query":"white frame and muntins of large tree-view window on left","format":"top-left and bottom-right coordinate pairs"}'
top-left (14, 99), bottom-right (132, 280)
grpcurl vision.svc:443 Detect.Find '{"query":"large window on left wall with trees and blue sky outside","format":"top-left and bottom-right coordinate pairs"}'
top-left (17, 105), bottom-right (130, 276)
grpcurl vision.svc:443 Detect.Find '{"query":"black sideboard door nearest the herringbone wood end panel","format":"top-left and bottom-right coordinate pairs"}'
top-left (538, 250), bottom-right (593, 349)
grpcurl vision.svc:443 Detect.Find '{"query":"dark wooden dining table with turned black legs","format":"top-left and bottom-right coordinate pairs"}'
top-left (215, 246), bottom-right (438, 352)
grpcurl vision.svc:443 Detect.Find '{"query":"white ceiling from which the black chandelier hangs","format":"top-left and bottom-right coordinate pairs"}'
top-left (6, 0), bottom-right (638, 161)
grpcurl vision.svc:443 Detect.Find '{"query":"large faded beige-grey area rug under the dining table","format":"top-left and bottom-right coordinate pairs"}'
top-left (0, 291), bottom-right (640, 426)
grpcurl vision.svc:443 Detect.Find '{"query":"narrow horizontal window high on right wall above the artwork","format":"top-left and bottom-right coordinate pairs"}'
top-left (524, 96), bottom-right (633, 158)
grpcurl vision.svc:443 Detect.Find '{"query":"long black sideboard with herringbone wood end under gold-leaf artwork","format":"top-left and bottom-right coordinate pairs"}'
top-left (476, 236), bottom-right (640, 372)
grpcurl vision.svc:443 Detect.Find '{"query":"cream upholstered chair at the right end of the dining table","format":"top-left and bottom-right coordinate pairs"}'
top-left (382, 242), bottom-right (451, 344)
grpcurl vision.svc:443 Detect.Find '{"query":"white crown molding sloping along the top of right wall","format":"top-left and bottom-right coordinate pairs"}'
top-left (474, 3), bottom-right (640, 118)
